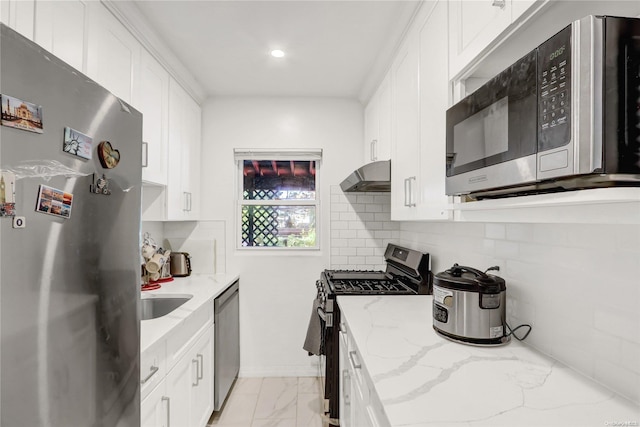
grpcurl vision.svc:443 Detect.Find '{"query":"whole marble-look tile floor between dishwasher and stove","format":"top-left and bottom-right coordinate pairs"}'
top-left (208, 377), bottom-right (327, 427)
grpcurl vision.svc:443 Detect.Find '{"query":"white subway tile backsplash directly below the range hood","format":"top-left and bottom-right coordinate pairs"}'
top-left (331, 185), bottom-right (400, 270)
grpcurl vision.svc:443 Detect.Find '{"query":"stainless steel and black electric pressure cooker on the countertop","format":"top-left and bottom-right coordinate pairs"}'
top-left (433, 264), bottom-right (510, 345)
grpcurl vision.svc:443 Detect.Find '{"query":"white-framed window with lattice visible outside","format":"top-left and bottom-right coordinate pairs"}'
top-left (235, 150), bottom-right (322, 249)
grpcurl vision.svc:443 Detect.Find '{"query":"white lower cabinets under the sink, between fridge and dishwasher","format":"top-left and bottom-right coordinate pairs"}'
top-left (140, 304), bottom-right (214, 427)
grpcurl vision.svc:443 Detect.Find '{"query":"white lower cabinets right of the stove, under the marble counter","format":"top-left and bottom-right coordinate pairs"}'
top-left (339, 323), bottom-right (390, 427)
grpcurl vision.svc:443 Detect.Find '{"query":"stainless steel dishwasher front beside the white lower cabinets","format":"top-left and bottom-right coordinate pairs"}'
top-left (213, 280), bottom-right (240, 411)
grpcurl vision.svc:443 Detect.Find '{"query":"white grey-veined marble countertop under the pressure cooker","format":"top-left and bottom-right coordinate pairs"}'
top-left (338, 295), bottom-right (640, 427)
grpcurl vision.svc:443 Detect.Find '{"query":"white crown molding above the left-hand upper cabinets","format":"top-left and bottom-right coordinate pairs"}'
top-left (100, 0), bottom-right (207, 104)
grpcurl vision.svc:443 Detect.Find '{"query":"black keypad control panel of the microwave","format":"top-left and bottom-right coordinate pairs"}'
top-left (538, 25), bottom-right (571, 152)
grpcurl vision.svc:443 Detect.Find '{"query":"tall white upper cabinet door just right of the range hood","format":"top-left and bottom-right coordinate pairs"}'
top-left (391, 31), bottom-right (420, 220)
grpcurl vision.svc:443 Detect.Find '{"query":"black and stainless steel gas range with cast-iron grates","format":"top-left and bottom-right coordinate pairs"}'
top-left (316, 244), bottom-right (431, 424)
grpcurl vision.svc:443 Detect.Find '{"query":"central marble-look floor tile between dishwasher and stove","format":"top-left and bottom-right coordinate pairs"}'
top-left (254, 378), bottom-right (298, 419)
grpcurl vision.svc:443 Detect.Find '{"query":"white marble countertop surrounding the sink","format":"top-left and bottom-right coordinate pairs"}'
top-left (140, 274), bottom-right (238, 353)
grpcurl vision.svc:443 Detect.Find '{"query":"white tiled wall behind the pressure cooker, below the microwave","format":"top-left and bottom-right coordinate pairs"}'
top-left (401, 223), bottom-right (640, 403)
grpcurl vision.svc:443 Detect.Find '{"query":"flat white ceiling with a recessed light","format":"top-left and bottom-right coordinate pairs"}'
top-left (135, 0), bottom-right (419, 102)
